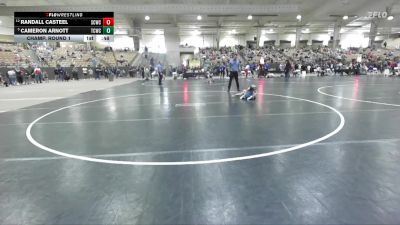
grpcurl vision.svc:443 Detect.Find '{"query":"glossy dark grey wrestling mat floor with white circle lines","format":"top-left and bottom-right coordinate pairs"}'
top-left (0, 77), bottom-right (400, 224)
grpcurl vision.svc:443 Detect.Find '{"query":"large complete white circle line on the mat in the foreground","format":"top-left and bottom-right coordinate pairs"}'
top-left (25, 91), bottom-right (345, 166)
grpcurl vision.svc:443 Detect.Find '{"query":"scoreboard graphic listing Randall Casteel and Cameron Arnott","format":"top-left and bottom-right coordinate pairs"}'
top-left (14, 12), bottom-right (114, 42)
